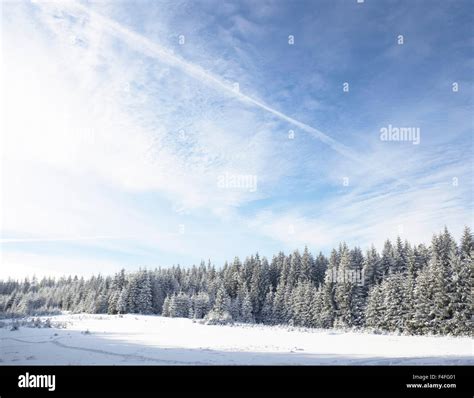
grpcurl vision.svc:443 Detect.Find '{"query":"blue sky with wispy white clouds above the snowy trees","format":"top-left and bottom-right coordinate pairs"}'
top-left (0, 0), bottom-right (474, 277)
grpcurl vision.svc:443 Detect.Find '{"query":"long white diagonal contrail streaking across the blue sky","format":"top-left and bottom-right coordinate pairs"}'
top-left (40, 1), bottom-right (410, 186)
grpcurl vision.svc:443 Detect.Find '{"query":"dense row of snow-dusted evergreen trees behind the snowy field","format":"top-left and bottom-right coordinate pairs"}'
top-left (0, 227), bottom-right (474, 335)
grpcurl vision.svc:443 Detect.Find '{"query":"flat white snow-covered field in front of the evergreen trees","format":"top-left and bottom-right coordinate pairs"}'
top-left (0, 314), bottom-right (474, 365)
